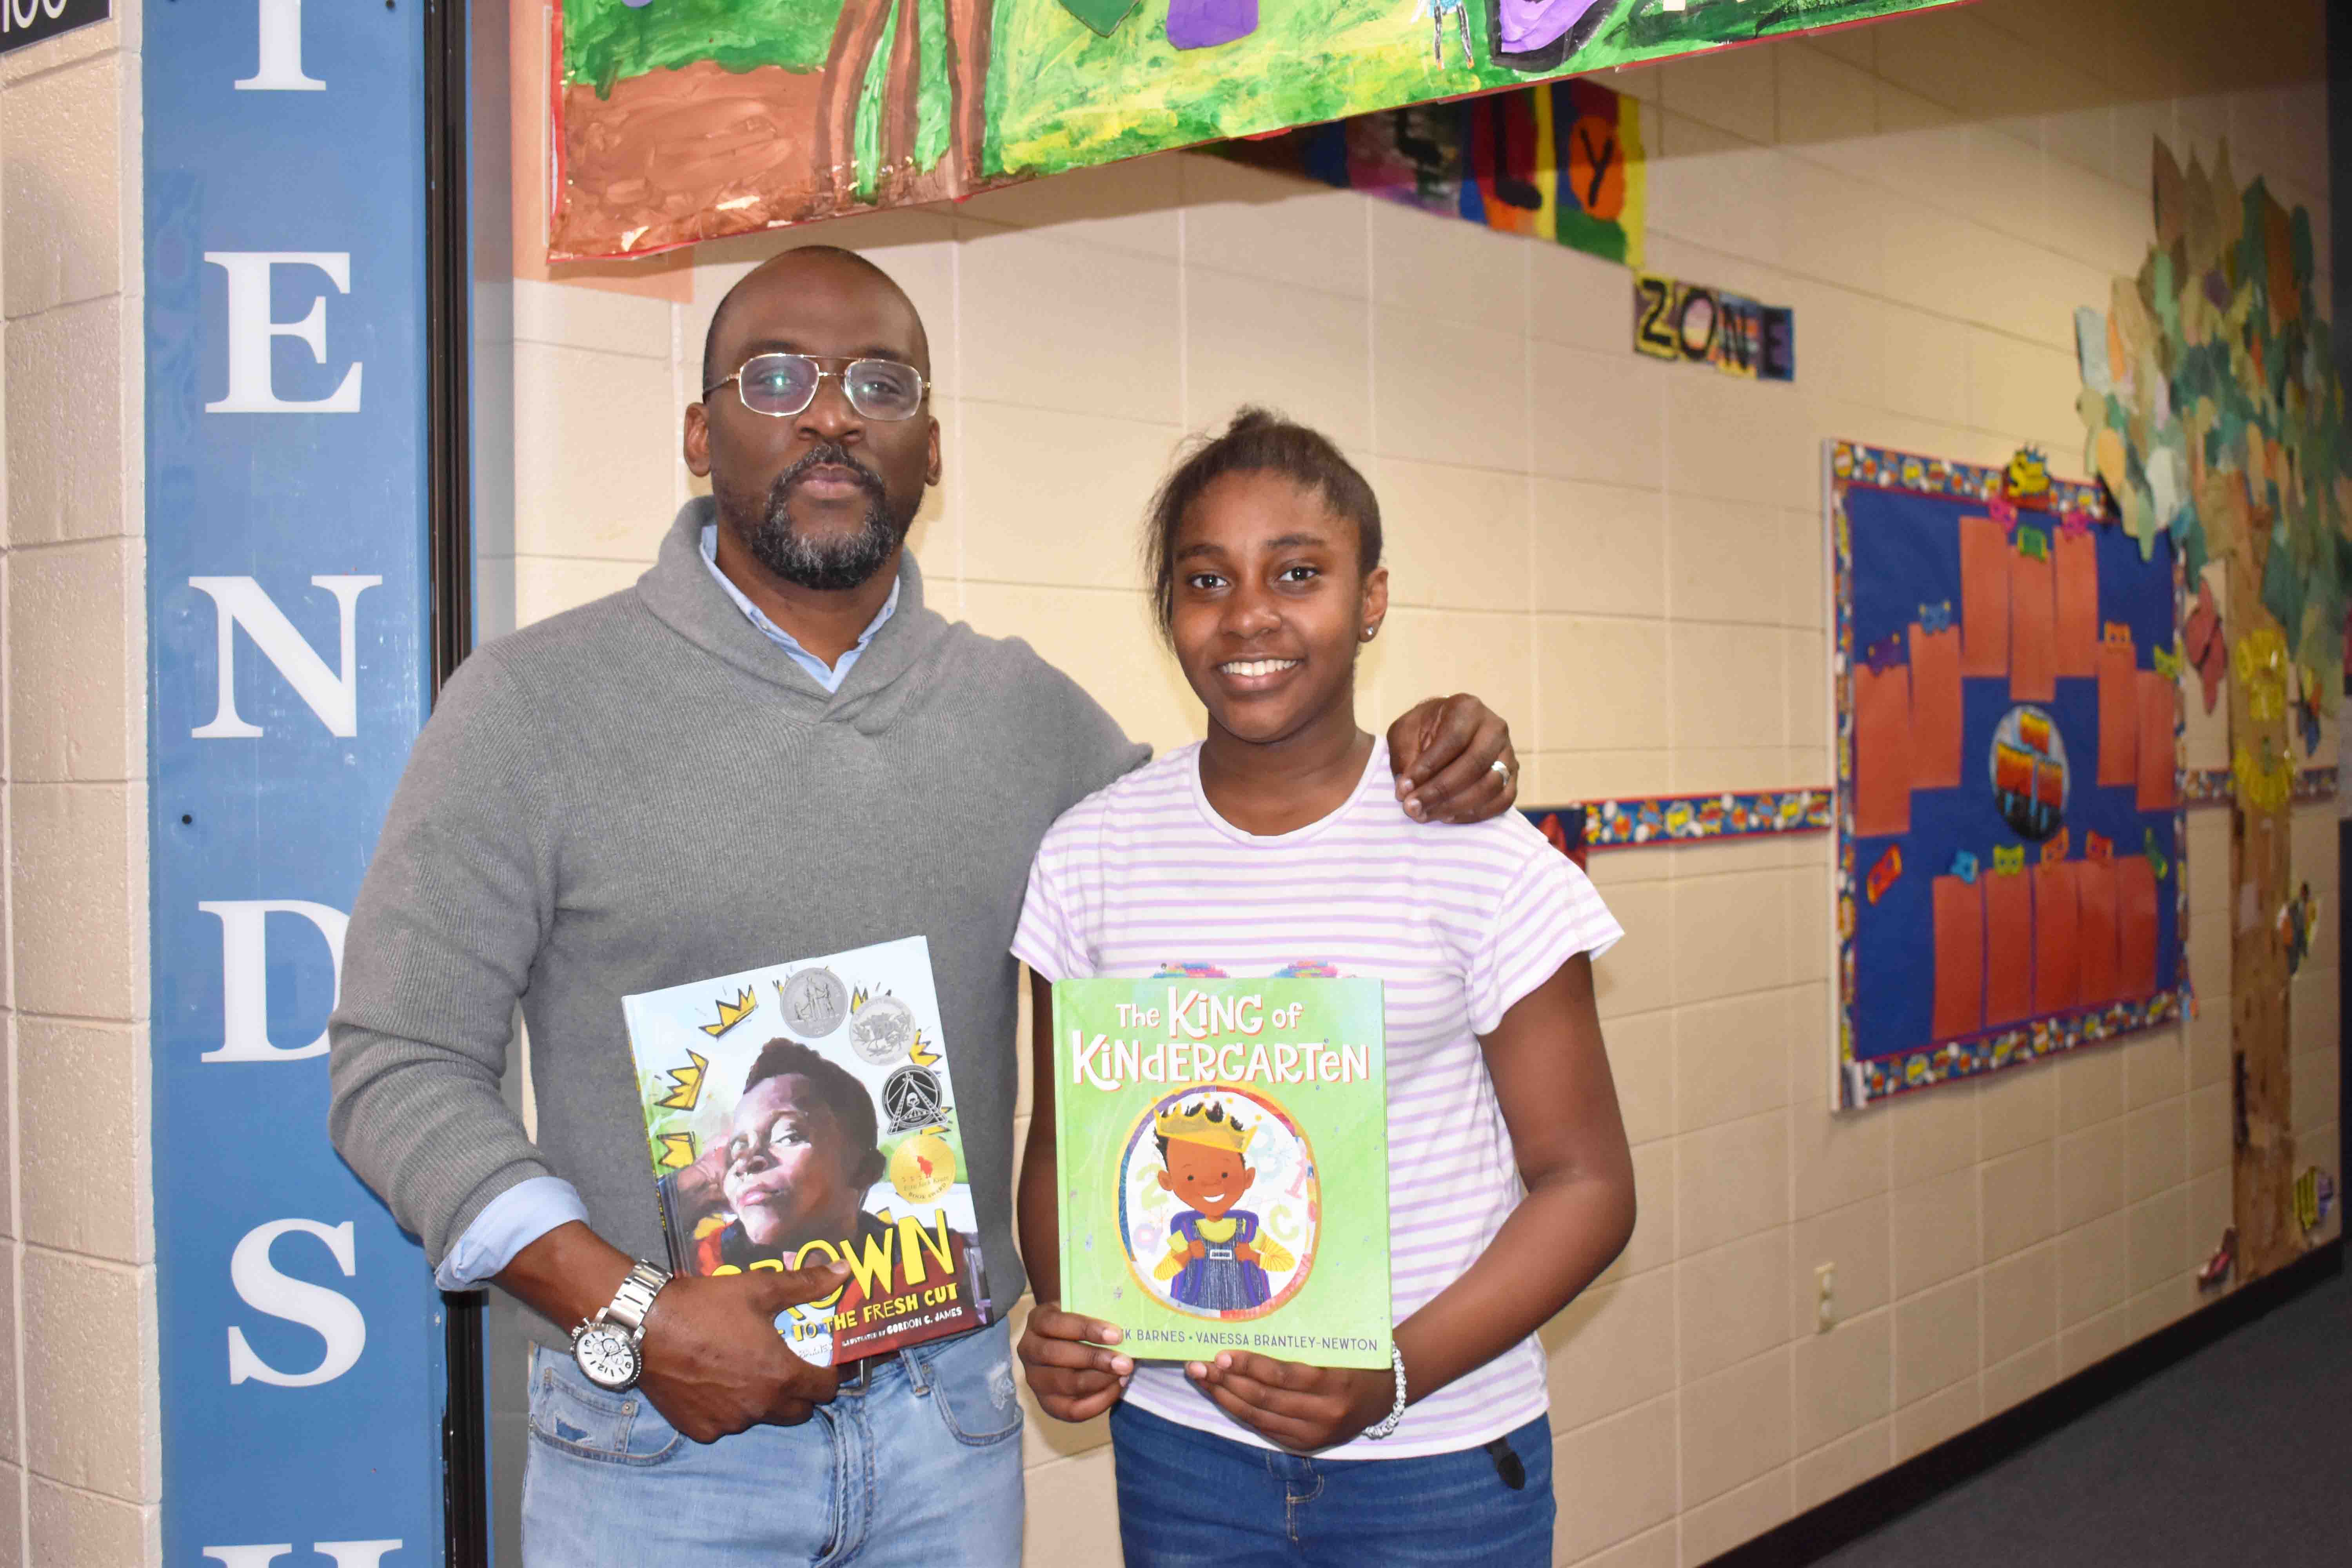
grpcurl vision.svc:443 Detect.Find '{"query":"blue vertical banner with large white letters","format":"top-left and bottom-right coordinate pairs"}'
top-left (143, 0), bottom-right (447, 1568)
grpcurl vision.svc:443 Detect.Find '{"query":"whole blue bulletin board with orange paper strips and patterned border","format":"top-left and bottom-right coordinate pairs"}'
top-left (1827, 442), bottom-right (2187, 1110)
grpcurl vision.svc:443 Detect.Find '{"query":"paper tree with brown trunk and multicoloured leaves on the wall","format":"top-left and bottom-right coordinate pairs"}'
top-left (2074, 141), bottom-right (2352, 1283)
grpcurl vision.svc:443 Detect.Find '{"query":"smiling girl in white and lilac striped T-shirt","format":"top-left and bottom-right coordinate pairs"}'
top-left (1014, 409), bottom-right (1635, 1568)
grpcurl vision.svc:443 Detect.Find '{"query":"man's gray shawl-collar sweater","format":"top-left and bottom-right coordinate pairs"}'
top-left (329, 498), bottom-right (1148, 1345)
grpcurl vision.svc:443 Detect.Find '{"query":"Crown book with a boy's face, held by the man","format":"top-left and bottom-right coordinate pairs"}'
top-left (623, 936), bottom-right (988, 1366)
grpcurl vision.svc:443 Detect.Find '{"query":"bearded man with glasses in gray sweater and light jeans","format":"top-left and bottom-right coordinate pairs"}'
top-left (329, 247), bottom-right (1512, 1568)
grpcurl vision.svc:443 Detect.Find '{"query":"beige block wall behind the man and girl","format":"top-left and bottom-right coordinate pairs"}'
top-left (501, 0), bottom-right (2338, 1568)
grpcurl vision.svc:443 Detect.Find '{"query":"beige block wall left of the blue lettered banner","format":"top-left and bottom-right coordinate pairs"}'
top-left (0, 0), bottom-right (162, 1566)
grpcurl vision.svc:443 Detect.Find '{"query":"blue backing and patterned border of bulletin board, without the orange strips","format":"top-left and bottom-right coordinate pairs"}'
top-left (1830, 442), bottom-right (2187, 1107)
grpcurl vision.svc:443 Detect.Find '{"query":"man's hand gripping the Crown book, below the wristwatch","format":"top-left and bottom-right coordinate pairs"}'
top-left (637, 1262), bottom-right (849, 1443)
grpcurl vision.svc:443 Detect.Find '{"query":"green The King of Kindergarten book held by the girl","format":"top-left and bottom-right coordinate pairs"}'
top-left (1054, 976), bottom-right (1390, 1366)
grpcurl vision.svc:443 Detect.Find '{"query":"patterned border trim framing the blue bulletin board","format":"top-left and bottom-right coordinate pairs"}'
top-left (1823, 439), bottom-right (2192, 1110)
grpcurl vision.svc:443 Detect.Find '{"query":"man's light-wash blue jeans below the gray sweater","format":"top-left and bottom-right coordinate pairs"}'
top-left (522, 1323), bottom-right (1021, 1568)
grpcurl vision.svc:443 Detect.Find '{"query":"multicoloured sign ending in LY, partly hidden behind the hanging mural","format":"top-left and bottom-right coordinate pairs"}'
top-left (1223, 76), bottom-right (1646, 268)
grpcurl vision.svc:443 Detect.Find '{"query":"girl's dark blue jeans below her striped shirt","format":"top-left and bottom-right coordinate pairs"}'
top-left (1110, 1403), bottom-right (1552, 1568)
